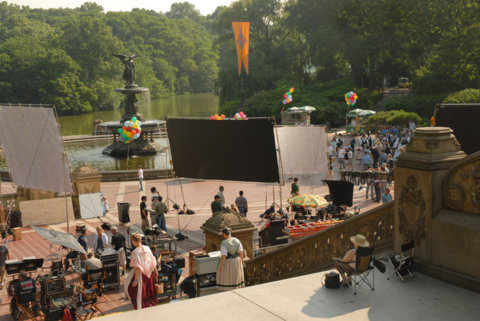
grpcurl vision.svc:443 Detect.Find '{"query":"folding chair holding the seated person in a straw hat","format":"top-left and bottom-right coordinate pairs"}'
top-left (351, 246), bottom-right (375, 295)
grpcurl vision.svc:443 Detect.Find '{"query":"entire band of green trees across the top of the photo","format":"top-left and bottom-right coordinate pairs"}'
top-left (0, 0), bottom-right (480, 120)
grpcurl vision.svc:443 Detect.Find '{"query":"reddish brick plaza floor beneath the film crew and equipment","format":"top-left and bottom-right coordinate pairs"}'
top-left (0, 159), bottom-right (386, 320)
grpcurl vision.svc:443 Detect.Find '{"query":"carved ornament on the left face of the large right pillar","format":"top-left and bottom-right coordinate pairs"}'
top-left (398, 175), bottom-right (426, 244)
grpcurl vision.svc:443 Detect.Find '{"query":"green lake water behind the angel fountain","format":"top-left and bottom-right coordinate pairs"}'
top-left (59, 93), bottom-right (218, 136)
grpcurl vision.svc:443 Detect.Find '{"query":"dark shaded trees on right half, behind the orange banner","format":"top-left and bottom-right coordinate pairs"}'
top-left (214, 0), bottom-right (480, 123)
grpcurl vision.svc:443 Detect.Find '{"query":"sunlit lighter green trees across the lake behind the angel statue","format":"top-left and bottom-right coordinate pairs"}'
top-left (0, 2), bottom-right (218, 114)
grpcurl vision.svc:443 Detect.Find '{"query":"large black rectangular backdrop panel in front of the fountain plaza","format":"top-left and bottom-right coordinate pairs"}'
top-left (167, 118), bottom-right (280, 182)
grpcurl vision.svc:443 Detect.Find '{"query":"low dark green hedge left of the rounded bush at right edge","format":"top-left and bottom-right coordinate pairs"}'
top-left (385, 94), bottom-right (446, 118)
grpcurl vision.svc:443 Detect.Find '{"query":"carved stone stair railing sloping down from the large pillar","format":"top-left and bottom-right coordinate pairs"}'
top-left (245, 202), bottom-right (394, 285)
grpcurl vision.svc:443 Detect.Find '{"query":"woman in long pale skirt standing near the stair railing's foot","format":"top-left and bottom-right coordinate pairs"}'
top-left (216, 227), bottom-right (245, 291)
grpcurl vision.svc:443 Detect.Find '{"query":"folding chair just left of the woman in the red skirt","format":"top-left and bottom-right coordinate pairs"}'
top-left (76, 268), bottom-right (106, 321)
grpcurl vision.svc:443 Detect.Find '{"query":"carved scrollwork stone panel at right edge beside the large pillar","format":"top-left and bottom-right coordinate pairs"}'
top-left (444, 152), bottom-right (480, 214)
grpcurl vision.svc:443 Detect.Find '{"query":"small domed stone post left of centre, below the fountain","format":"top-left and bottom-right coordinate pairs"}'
top-left (72, 163), bottom-right (102, 218)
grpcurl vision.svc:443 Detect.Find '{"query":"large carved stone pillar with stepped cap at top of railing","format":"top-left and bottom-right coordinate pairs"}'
top-left (394, 127), bottom-right (466, 262)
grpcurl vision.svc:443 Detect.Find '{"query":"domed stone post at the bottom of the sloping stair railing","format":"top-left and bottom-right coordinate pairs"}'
top-left (201, 212), bottom-right (256, 258)
